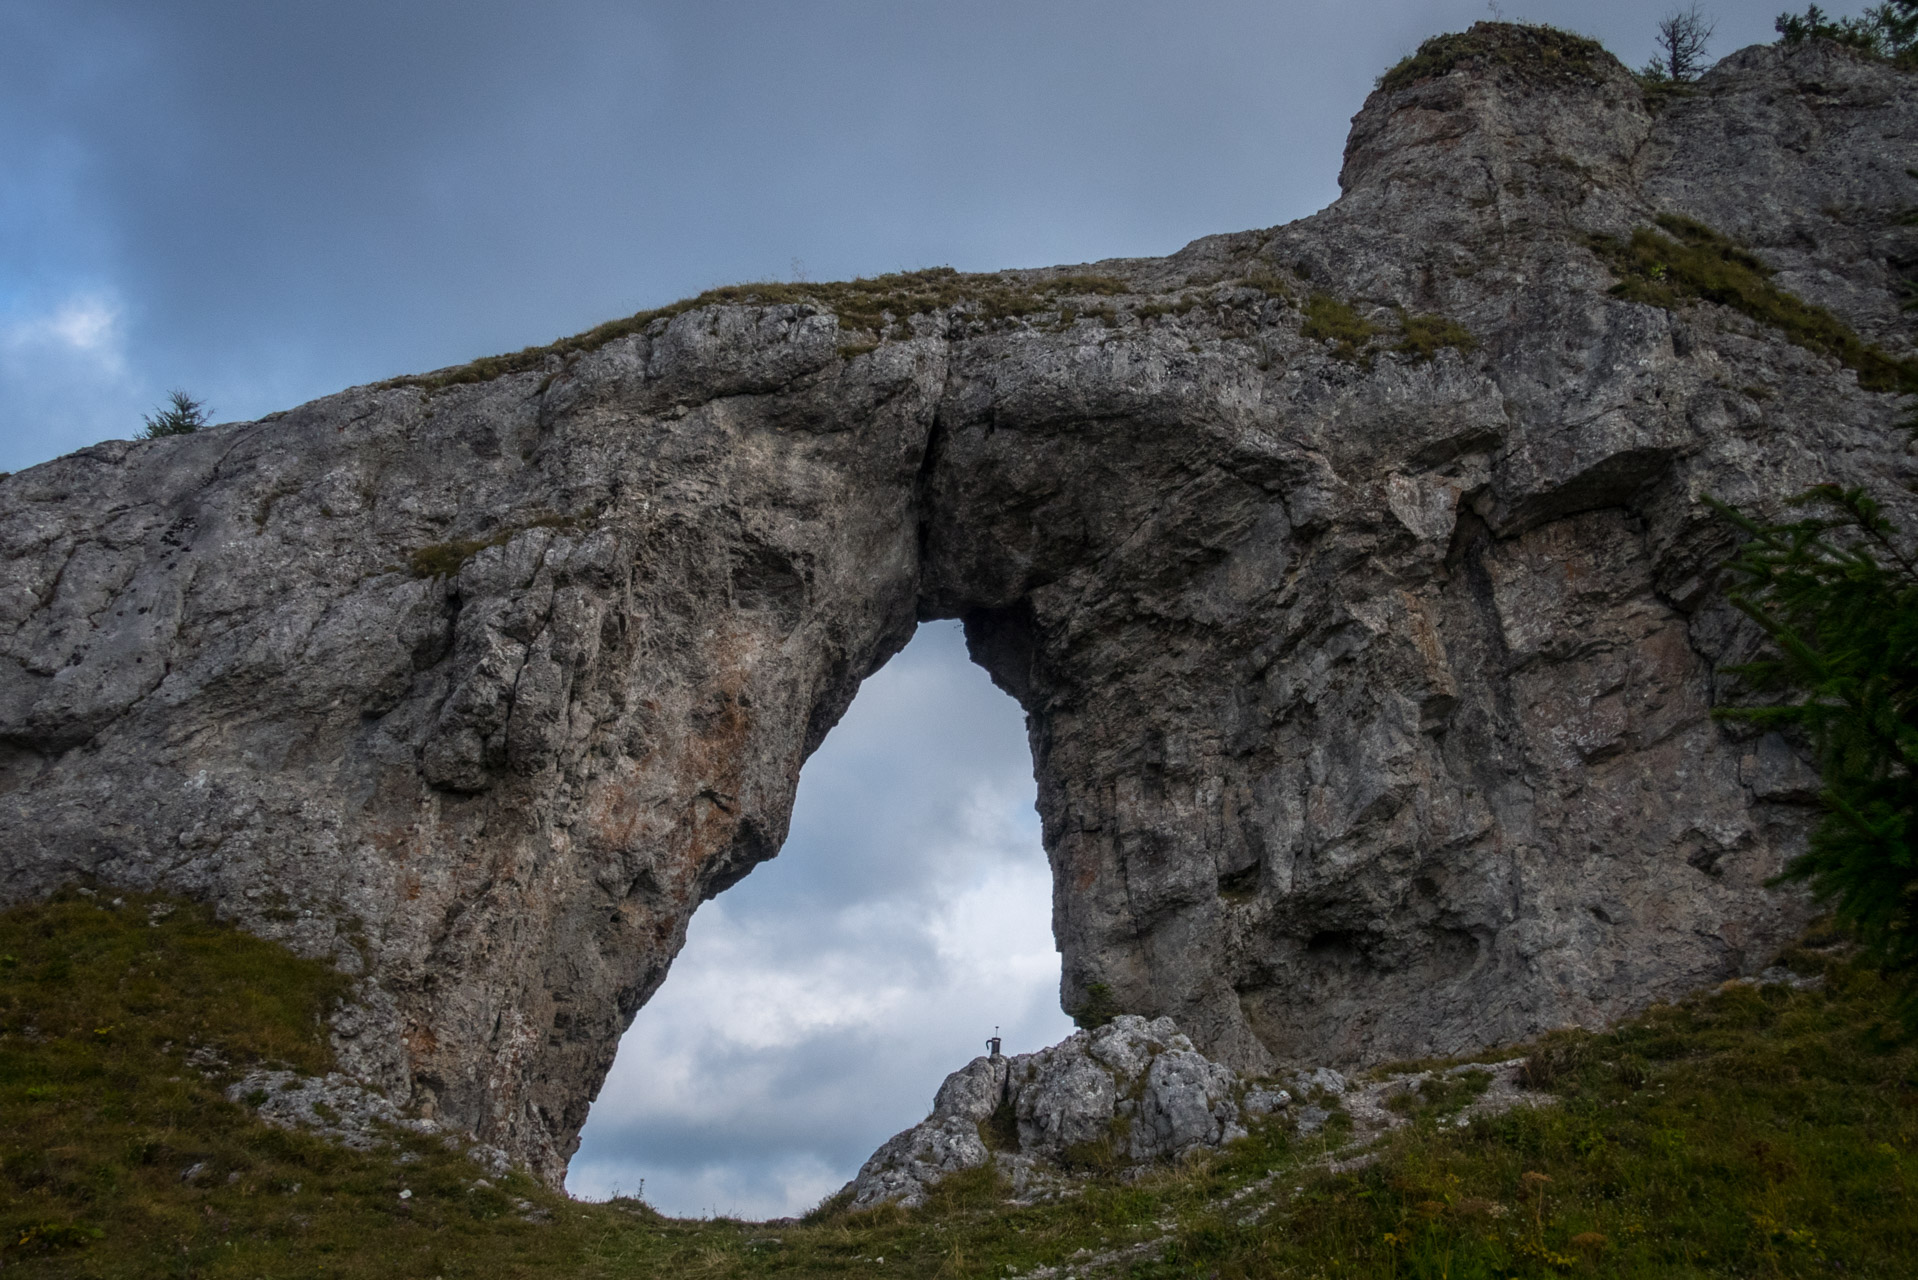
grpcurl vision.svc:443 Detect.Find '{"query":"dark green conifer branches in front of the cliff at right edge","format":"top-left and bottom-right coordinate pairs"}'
top-left (1715, 486), bottom-right (1918, 1031)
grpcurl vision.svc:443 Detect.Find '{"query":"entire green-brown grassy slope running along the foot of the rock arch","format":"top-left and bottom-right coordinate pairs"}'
top-left (0, 896), bottom-right (1918, 1280)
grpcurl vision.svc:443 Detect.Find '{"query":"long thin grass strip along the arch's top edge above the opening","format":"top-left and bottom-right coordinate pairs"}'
top-left (380, 267), bottom-right (1132, 391)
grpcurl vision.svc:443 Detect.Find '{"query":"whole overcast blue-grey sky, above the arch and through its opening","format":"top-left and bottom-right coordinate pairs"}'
top-left (0, 0), bottom-right (1825, 1215)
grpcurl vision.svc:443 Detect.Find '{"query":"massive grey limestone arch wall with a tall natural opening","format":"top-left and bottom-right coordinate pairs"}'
top-left (0, 25), bottom-right (1918, 1184)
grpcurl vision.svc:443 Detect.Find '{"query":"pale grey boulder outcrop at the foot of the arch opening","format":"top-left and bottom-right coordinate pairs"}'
top-left (842, 1013), bottom-right (1258, 1209)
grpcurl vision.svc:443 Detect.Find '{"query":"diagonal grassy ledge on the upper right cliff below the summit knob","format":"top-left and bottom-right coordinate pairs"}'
top-left (1590, 215), bottom-right (1918, 393)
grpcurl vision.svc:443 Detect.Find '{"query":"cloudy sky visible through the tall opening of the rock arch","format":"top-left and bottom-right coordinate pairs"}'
top-left (568, 624), bottom-right (1070, 1217)
